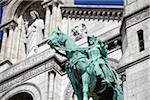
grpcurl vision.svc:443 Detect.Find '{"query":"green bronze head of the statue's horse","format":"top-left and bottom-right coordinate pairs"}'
top-left (48, 29), bottom-right (65, 48)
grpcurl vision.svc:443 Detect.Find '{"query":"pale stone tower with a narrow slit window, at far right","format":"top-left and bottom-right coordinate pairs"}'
top-left (120, 0), bottom-right (150, 100)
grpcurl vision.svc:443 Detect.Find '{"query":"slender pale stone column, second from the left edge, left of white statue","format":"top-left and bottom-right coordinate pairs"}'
top-left (6, 23), bottom-right (14, 59)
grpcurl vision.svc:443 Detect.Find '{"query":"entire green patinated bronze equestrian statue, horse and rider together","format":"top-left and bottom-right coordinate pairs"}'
top-left (48, 29), bottom-right (123, 100)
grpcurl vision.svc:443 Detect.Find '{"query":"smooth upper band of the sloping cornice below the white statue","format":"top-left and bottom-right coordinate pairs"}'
top-left (0, 49), bottom-right (55, 83)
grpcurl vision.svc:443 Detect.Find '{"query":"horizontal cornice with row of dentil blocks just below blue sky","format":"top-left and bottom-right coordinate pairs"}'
top-left (61, 6), bottom-right (123, 21)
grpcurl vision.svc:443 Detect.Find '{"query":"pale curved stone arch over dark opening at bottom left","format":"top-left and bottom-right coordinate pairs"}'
top-left (0, 83), bottom-right (41, 100)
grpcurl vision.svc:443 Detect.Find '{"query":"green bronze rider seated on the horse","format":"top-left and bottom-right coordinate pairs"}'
top-left (88, 36), bottom-right (112, 82)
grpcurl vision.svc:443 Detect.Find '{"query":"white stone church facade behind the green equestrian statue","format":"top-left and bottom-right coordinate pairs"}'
top-left (0, 0), bottom-right (150, 100)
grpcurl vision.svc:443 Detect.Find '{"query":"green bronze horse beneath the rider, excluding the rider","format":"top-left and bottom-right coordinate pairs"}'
top-left (48, 29), bottom-right (123, 100)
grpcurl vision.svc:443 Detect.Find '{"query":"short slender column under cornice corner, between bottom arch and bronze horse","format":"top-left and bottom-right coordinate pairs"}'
top-left (48, 72), bottom-right (55, 100)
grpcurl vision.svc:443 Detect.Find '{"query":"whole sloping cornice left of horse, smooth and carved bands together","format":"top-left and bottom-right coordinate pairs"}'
top-left (0, 49), bottom-right (66, 93)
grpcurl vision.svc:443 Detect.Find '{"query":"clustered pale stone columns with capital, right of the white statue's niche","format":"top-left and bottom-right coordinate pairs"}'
top-left (42, 0), bottom-right (62, 34)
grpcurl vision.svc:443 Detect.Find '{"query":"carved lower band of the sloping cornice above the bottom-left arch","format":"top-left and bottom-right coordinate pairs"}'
top-left (0, 59), bottom-right (64, 93)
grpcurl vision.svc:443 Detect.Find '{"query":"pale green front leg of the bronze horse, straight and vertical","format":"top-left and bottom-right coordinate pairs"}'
top-left (82, 72), bottom-right (90, 100)
